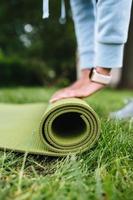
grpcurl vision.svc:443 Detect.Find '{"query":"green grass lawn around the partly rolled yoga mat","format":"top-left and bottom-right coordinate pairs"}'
top-left (0, 88), bottom-right (133, 200)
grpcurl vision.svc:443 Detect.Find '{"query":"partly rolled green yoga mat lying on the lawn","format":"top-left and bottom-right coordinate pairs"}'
top-left (0, 98), bottom-right (100, 156)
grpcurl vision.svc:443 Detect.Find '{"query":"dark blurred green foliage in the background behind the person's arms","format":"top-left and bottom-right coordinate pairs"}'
top-left (0, 0), bottom-right (133, 88)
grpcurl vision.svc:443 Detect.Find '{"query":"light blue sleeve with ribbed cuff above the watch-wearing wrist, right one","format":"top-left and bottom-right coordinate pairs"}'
top-left (95, 0), bottom-right (132, 68)
